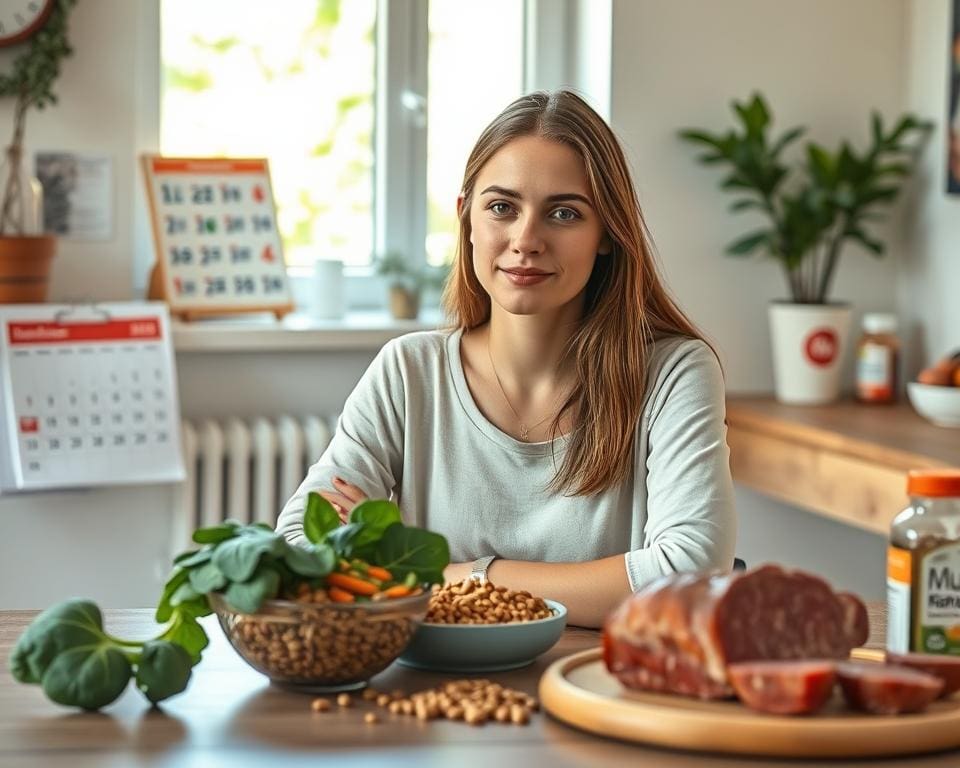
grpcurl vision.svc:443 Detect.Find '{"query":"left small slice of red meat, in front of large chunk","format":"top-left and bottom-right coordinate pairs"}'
top-left (727, 660), bottom-right (837, 715)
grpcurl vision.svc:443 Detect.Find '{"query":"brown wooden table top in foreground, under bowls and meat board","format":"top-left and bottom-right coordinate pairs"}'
top-left (0, 605), bottom-right (960, 768)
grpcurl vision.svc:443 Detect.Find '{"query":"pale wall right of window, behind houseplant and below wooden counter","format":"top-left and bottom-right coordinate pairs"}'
top-left (612, 0), bottom-right (912, 598)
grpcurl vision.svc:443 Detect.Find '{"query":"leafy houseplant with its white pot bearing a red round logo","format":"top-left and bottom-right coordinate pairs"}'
top-left (679, 94), bottom-right (932, 403)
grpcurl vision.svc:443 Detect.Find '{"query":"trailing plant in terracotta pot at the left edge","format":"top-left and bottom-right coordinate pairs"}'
top-left (0, 0), bottom-right (76, 303)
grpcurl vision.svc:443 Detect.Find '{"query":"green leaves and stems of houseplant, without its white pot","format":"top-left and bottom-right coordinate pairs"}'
top-left (679, 94), bottom-right (932, 304)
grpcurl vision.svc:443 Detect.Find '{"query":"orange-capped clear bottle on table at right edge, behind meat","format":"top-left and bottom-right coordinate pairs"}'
top-left (887, 469), bottom-right (960, 655)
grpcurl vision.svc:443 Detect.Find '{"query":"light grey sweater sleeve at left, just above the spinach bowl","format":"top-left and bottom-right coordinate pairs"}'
top-left (277, 341), bottom-right (405, 542)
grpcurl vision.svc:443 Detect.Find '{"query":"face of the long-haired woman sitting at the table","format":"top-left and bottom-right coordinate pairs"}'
top-left (470, 136), bottom-right (610, 315)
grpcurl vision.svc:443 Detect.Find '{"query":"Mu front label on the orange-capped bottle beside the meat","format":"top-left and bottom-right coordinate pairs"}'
top-left (914, 541), bottom-right (960, 654)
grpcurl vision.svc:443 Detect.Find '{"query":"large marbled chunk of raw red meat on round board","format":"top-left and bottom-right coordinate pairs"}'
top-left (603, 565), bottom-right (866, 698)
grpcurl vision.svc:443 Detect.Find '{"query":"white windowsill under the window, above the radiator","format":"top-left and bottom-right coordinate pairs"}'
top-left (171, 308), bottom-right (442, 353)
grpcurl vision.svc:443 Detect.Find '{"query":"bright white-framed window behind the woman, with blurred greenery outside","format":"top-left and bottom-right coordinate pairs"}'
top-left (160, 0), bottom-right (568, 304)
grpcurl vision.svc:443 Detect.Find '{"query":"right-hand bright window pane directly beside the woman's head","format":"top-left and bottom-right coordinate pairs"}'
top-left (426, 0), bottom-right (523, 265)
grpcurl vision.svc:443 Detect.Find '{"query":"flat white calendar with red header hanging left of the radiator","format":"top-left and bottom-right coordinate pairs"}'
top-left (0, 303), bottom-right (184, 493)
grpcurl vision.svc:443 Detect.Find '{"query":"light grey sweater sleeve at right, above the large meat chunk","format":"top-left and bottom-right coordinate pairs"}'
top-left (626, 341), bottom-right (737, 591)
